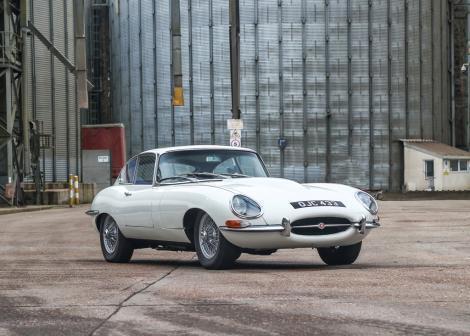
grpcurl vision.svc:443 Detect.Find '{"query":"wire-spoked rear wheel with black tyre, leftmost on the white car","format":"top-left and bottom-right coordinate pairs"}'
top-left (100, 216), bottom-right (134, 263)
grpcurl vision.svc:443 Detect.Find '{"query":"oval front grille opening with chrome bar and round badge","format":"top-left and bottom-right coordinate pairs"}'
top-left (291, 217), bottom-right (351, 236)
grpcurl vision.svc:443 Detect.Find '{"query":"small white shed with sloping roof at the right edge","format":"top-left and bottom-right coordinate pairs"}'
top-left (401, 139), bottom-right (470, 191)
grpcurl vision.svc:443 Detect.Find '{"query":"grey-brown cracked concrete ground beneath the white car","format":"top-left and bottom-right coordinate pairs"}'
top-left (0, 201), bottom-right (470, 335)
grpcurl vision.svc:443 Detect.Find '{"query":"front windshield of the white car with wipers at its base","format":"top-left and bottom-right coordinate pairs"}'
top-left (157, 150), bottom-right (268, 182)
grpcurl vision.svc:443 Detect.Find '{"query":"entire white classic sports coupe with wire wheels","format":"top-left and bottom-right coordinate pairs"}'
top-left (87, 146), bottom-right (380, 269)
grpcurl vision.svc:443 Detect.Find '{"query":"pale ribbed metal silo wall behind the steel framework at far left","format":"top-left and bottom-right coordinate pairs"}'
top-left (26, 0), bottom-right (80, 181)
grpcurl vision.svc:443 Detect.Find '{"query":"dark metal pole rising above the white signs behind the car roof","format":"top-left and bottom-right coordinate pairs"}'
top-left (229, 0), bottom-right (241, 119)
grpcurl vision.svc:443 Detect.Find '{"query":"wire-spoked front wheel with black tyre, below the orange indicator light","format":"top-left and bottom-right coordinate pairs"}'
top-left (194, 213), bottom-right (241, 269)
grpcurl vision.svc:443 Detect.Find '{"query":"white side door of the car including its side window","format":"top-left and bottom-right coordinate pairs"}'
top-left (118, 153), bottom-right (156, 228)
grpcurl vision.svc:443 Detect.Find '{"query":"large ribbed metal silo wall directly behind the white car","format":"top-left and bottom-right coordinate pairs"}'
top-left (110, 0), bottom-right (452, 190)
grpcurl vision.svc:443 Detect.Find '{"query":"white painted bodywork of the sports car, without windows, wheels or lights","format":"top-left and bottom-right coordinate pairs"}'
top-left (88, 146), bottom-right (379, 266)
